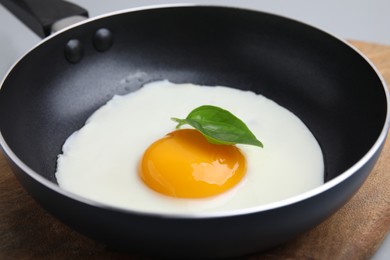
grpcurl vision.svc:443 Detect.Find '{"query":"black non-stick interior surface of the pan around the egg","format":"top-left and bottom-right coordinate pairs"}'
top-left (0, 7), bottom-right (387, 185)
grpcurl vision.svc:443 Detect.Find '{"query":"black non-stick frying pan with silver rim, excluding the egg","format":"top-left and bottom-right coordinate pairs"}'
top-left (0, 0), bottom-right (389, 258)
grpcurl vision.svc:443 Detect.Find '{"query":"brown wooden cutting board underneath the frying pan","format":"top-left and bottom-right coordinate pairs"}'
top-left (0, 41), bottom-right (390, 260)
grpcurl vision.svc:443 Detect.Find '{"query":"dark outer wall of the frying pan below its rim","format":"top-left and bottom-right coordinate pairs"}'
top-left (5, 140), bottom-right (382, 259)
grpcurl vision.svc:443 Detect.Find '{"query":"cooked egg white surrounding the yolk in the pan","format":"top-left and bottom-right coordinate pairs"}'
top-left (56, 81), bottom-right (324, 213)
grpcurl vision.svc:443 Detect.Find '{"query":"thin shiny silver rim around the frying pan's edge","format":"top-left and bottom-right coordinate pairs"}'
top-left (0, 3), bottom-right (390, 219)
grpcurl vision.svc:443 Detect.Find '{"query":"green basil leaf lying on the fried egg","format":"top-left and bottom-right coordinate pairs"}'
top-left (172, 105), bottom-right (263, 147)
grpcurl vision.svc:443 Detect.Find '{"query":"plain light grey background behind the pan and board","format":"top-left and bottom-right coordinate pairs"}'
top-left (0, 0), bottom-right (390, 260)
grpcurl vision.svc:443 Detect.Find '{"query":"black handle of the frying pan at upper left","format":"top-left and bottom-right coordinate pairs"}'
top-left (0, 0), bottom-right (88, 38)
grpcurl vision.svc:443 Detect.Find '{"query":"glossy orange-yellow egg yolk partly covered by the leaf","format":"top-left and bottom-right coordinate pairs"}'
top-left (140, 129), bottom-right (246, 198)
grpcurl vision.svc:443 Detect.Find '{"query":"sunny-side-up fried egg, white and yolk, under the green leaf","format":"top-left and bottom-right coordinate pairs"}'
top-left (56, 81), bottom-right (324, 214)
